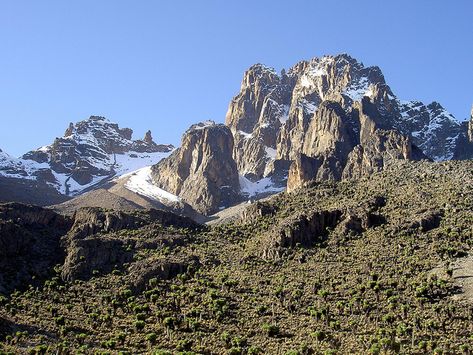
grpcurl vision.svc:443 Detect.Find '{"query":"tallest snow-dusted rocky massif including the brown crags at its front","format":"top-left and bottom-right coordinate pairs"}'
top-left (226, 55), bottom-right (473, 190)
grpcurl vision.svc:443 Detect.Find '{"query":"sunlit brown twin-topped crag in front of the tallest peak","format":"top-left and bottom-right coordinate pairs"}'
top-left (287, 97), bottom-right (427, 192)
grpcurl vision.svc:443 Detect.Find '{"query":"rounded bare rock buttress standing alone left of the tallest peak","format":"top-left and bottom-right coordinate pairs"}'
top-left (152, 122), bottom-right (240, 214)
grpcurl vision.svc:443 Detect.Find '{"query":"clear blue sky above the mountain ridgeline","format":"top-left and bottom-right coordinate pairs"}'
top-left (0, 0), bottom-right (473, 155)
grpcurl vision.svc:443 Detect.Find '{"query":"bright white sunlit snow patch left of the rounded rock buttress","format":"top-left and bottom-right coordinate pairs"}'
top-left (125, 166), bottom-right (181, 203)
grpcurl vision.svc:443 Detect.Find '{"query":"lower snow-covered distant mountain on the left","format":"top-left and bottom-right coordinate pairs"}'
top-left (0, 116), bottom-right (174, 204)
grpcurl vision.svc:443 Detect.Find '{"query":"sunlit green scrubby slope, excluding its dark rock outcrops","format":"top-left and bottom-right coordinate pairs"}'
top-left (0, 162), bottom-right (473, 354)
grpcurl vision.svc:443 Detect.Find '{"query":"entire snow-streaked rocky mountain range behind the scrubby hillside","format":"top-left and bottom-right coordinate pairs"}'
top-left (0, 54), bottom-right (473, 220)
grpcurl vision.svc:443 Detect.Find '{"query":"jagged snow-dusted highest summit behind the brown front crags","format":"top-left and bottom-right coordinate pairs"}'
top-left (225, 54), bottom-right (464, 189)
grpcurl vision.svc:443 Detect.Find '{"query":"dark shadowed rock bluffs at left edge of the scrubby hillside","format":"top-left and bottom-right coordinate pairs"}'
top-left (0, 203), bottom-right (201, 294)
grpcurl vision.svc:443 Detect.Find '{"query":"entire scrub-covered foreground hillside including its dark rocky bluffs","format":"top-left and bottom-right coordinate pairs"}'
top-left (0, 161), bottom-right (473, 354)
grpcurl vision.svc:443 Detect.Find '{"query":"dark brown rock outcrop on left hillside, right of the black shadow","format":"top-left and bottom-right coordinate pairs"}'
top-left (62, 208), bottom-right (200, 281)
